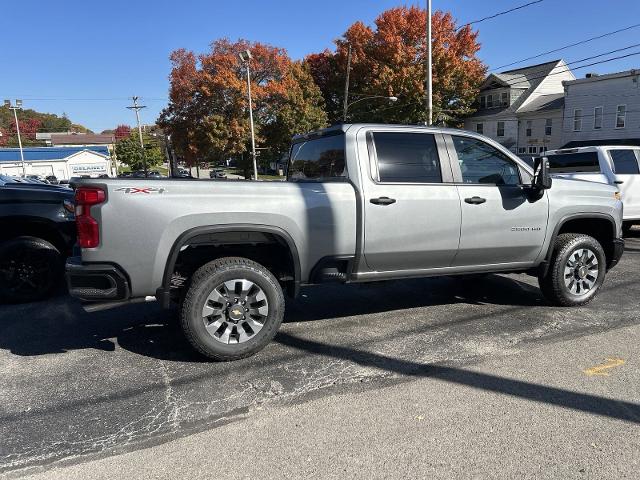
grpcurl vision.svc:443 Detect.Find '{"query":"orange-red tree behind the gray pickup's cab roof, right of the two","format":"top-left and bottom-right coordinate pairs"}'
top-left (305, 7), bottom-right (486, 123)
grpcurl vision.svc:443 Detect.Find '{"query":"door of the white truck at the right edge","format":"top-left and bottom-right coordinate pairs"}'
top-left (609, 148), bottom-right (640, 220)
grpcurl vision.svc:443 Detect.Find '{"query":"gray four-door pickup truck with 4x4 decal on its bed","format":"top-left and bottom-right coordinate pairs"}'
top-left (67, 124), bottom-right (624, 360)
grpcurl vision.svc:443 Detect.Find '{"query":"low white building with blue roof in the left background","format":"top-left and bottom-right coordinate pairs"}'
top-left (0, 145), bottom-right (114, 180)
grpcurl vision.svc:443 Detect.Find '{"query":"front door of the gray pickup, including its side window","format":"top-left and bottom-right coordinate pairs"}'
top-left (447, 135), bottom-right (549, 266)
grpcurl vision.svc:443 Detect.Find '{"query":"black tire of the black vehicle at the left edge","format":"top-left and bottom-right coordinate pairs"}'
top-left (0, 236), bottom-right (64, 303)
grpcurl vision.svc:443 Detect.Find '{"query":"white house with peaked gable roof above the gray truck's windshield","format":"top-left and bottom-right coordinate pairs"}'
top-left (465, 60), bottom-right (575, 155)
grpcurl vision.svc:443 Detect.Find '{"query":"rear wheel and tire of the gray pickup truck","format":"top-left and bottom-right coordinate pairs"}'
top-left (180, 257), bottom-right (285, 361)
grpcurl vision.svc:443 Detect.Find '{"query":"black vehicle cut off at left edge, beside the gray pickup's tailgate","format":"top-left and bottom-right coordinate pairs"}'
top-left (0, 175), bottom-right (76, 302)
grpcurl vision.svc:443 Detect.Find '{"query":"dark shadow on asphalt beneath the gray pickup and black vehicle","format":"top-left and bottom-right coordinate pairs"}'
top-left (0, 275), bottom-right (544, 362)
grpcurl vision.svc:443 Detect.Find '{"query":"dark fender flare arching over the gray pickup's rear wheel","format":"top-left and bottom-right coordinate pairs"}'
top-left (156, 223), bottom-right (302, 308)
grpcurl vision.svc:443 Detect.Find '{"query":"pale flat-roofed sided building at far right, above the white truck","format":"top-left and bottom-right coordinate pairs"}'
top-left (562, 70), bottom-right (640, 147)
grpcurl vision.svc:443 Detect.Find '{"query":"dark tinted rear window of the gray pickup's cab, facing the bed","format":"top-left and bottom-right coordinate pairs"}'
top-left (288, 134), bottom-right (347, 182)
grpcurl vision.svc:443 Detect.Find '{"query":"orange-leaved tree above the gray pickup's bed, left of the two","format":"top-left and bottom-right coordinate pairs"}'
top-left (158, 39), bottom-right (326, 172)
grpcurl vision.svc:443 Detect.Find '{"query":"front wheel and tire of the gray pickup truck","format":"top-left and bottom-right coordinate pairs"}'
top-left (538, 233), bottom-right (607, 307)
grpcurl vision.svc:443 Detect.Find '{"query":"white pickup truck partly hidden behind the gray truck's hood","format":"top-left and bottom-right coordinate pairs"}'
top-left (546, 145), bottom-right (640, 233)
